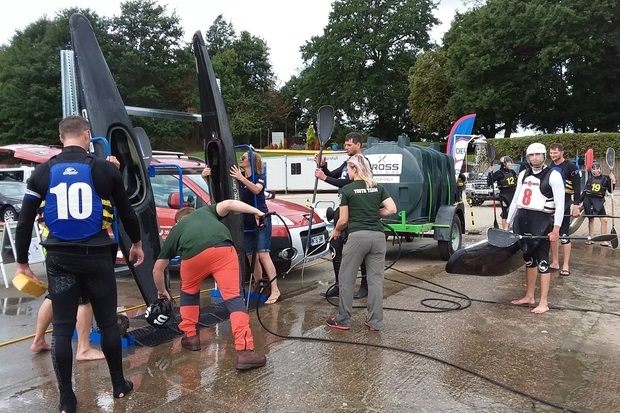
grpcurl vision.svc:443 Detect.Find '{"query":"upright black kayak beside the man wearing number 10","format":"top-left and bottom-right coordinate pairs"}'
top-left (69, 14), bottom-right (161, 304)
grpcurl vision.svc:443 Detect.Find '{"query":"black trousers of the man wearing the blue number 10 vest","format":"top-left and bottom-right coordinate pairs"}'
top-left (45, 247), bottom-right (124, 397)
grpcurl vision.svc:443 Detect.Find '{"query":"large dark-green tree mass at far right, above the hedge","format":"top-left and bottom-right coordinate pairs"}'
top-left (444, 0), bottom-right (620, 137)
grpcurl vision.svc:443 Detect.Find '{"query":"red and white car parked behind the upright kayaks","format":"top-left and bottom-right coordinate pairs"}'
top-left (0, 144), bottom-right (329, 274)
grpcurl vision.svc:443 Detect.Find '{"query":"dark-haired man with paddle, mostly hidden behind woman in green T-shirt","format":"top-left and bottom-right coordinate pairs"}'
top-left (314, 132), bottom-right (370, 298)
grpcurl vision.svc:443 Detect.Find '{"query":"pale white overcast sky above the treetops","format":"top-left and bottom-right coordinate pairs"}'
top-left (0, 0), bottom-right (465, 83)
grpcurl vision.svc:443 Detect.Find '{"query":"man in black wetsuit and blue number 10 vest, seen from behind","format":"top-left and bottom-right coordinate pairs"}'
top-left (15, 116), bottom-right (144, 413)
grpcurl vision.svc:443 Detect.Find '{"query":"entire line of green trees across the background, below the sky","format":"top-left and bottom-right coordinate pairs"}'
top-left (0, 0), bottom-right (620, 150)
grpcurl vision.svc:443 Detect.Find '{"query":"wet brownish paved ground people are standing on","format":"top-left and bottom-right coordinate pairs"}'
top-left (0, 199), bottom-right (620, 413)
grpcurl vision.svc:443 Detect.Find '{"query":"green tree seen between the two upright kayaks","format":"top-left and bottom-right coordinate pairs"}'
top-left (106, 0), bottom-right (196, 150)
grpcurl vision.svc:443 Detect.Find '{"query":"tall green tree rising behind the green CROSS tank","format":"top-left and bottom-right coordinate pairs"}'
top-left (300, 0), bottom-right (438, 139)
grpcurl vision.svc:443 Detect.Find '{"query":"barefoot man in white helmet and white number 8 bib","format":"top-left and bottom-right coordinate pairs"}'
top-left (507, 143), bottom-right (564, 314)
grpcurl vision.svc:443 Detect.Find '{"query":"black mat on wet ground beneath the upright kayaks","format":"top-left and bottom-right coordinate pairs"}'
top-left (128, 303), bottom-right (235, 347)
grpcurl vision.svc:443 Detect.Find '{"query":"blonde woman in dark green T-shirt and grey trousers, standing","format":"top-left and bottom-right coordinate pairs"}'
top-left (327, 154), bottom-right (396, 330)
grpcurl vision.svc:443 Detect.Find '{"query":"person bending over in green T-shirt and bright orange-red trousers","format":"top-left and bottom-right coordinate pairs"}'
top-left (153, 199), bottom-right (267, 370)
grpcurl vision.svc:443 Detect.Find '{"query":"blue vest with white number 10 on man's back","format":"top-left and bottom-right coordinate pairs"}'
top-left (43, 158), bottom-right (104, 241)
